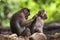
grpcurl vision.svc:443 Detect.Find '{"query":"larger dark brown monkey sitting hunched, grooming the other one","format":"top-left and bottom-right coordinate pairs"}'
top-left (10, 8), bottom-right (32, 36)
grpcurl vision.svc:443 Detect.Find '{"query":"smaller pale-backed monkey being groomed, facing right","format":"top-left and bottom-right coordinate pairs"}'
top-left (29, 10), bottom-right (47, 34)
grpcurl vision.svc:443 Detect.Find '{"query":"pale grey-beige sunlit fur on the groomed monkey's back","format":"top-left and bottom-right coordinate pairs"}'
top-left (34, 17), bottom-right (44, 32)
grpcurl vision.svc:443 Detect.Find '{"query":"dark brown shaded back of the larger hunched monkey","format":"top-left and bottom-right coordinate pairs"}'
top-left (10, 14), bottom-right (18, 33)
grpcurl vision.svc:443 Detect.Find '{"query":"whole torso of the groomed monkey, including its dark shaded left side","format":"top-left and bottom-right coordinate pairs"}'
top-left (30, 17), bottom-right (44, 34)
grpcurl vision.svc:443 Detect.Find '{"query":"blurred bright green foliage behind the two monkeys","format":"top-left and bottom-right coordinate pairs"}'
top-left (0, 0), bottom-right (60, 27)
